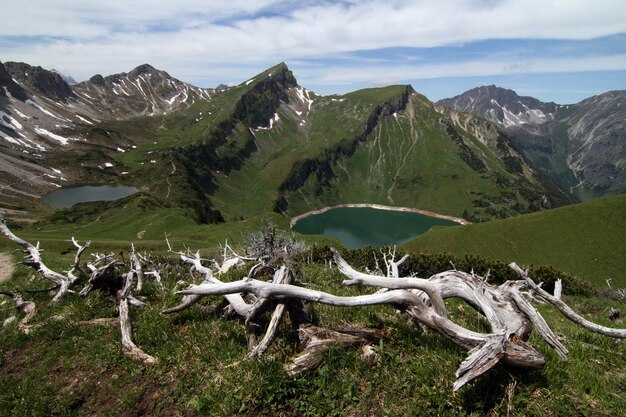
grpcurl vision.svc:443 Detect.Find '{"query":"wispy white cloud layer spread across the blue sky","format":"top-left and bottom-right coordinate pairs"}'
top-left (0, 0), bottom-right (626, 88)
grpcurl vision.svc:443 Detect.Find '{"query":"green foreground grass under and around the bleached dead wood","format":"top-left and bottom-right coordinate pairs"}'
top-left (0, 252), bottom-right (626, 417)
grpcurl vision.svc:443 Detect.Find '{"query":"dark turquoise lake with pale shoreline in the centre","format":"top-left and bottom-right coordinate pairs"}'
top-left (293, 207), bottom-right (459, 248)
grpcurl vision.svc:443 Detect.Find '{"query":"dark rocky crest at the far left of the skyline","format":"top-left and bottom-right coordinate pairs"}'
top-left (4, 62), bottom-right (74, 102)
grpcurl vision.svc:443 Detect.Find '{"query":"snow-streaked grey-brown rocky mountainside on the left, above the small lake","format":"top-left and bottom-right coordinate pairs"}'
top-left (0, 62), bottom-right (213, 216)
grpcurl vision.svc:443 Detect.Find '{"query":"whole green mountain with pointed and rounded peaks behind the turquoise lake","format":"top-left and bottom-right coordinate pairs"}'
top-left (29, 64), bottom-right (571, 232)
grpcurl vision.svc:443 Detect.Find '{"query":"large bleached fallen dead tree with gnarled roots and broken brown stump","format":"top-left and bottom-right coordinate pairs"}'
top-left (166, 247), bottom-right (626, 391)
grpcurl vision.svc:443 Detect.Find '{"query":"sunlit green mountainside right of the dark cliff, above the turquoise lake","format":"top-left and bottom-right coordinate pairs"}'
top-left (211, 86), bottom-right (571, 223)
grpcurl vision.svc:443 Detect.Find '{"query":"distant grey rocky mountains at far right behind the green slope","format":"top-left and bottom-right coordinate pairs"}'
top-left (439, 86), bottom-right (626, 199)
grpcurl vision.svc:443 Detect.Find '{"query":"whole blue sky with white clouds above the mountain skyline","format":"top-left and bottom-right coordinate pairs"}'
top-left (0, 0), bottom-right (626, 104)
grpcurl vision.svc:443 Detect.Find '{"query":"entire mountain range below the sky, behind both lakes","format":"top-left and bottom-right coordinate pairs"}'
top-left (0, 58), bottom-right (624, 223)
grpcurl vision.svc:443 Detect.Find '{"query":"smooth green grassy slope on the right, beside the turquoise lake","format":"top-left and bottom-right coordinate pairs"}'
top-left (403, 195), bottom-right (626, 287)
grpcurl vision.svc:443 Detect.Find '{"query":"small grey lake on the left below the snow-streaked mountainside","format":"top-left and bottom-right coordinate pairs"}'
top-left (41, 184), bottom-right (138, 208)
